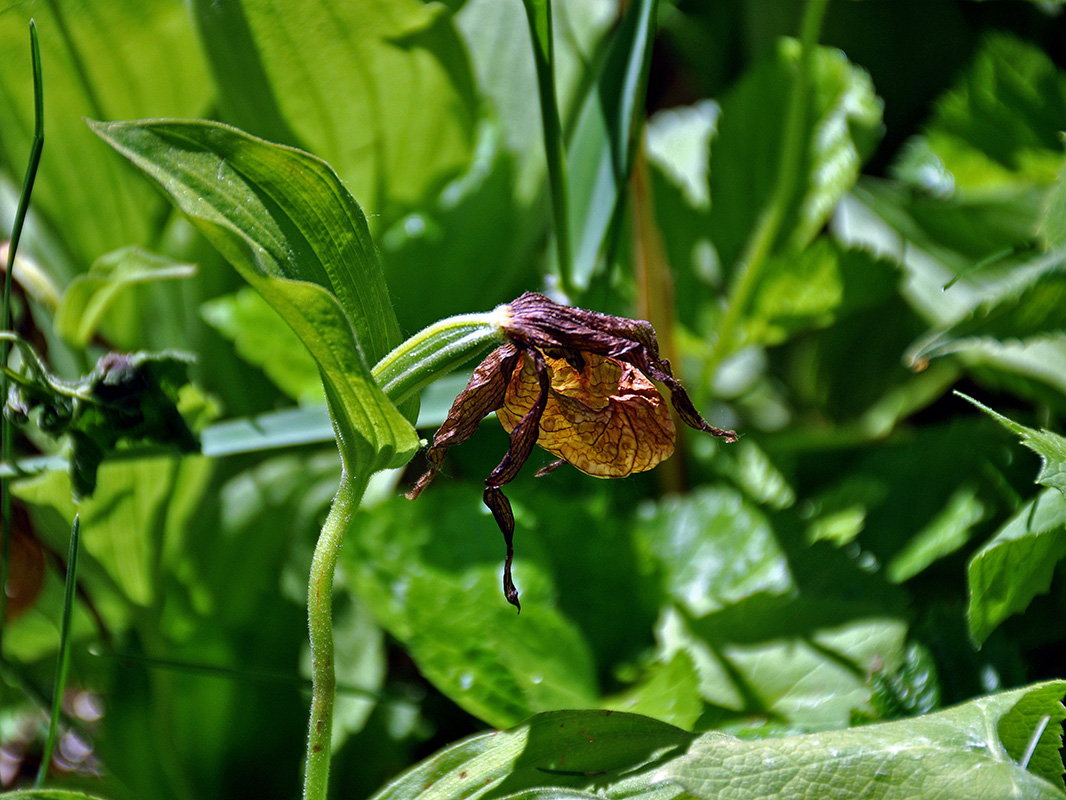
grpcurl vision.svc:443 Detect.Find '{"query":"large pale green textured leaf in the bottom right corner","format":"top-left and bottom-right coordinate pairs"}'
top-left (657, 681), bottom-right (1066, 800)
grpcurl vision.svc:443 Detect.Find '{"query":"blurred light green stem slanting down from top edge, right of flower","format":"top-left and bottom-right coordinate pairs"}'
top-left (708, 0), bottom-right (828, 377)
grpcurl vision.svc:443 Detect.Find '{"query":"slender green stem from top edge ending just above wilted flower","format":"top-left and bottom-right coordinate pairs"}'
top-left (522, 0), bottom-right (575, 299)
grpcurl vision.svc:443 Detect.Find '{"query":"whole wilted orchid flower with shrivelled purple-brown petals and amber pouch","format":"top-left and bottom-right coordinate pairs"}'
top-left (407, 292), bottom-right (737, 608)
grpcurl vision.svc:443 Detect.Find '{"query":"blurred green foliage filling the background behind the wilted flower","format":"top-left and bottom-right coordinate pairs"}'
top-left (0, 0), bottom-right (1066, 800)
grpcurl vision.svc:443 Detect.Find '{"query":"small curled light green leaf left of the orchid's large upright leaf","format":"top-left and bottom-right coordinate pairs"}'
top-left (54, 246), bottom-right (196, 347)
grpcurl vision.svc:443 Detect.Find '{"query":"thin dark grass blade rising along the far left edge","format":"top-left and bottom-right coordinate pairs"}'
top-left (0, 19), bottom-right (45, 659)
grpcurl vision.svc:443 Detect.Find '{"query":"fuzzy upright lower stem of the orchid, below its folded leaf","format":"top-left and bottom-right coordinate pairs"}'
top-left (304, 470), bottom-right (369, 800)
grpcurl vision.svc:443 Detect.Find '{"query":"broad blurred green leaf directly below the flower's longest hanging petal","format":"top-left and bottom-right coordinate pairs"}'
top-left (340, 484), bottom-right (597, 725)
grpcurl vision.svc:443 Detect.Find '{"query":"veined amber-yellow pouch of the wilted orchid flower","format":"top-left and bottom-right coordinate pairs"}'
top-left (496, 353), bottom-right (675, 478)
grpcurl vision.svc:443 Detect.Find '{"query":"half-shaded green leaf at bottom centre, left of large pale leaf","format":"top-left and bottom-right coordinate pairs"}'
top-left (373, 711), bottom-right (695, 800)
